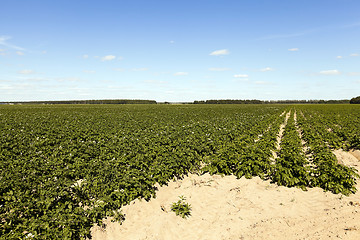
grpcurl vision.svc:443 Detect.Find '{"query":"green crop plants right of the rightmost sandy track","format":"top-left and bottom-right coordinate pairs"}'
top-left (299, 105), bottom-right (359, 195)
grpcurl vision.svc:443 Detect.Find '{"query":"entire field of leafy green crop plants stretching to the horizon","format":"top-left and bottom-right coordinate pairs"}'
top-left (0, 105), bottom-right (360, 239)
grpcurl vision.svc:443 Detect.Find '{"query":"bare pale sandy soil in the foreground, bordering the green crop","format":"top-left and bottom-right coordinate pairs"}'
top-left (92, 150), bottom-right (360, 240)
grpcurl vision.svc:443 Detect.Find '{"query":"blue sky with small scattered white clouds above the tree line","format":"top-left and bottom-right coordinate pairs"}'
top-left (0, 0), bottom-right (360, 102)
